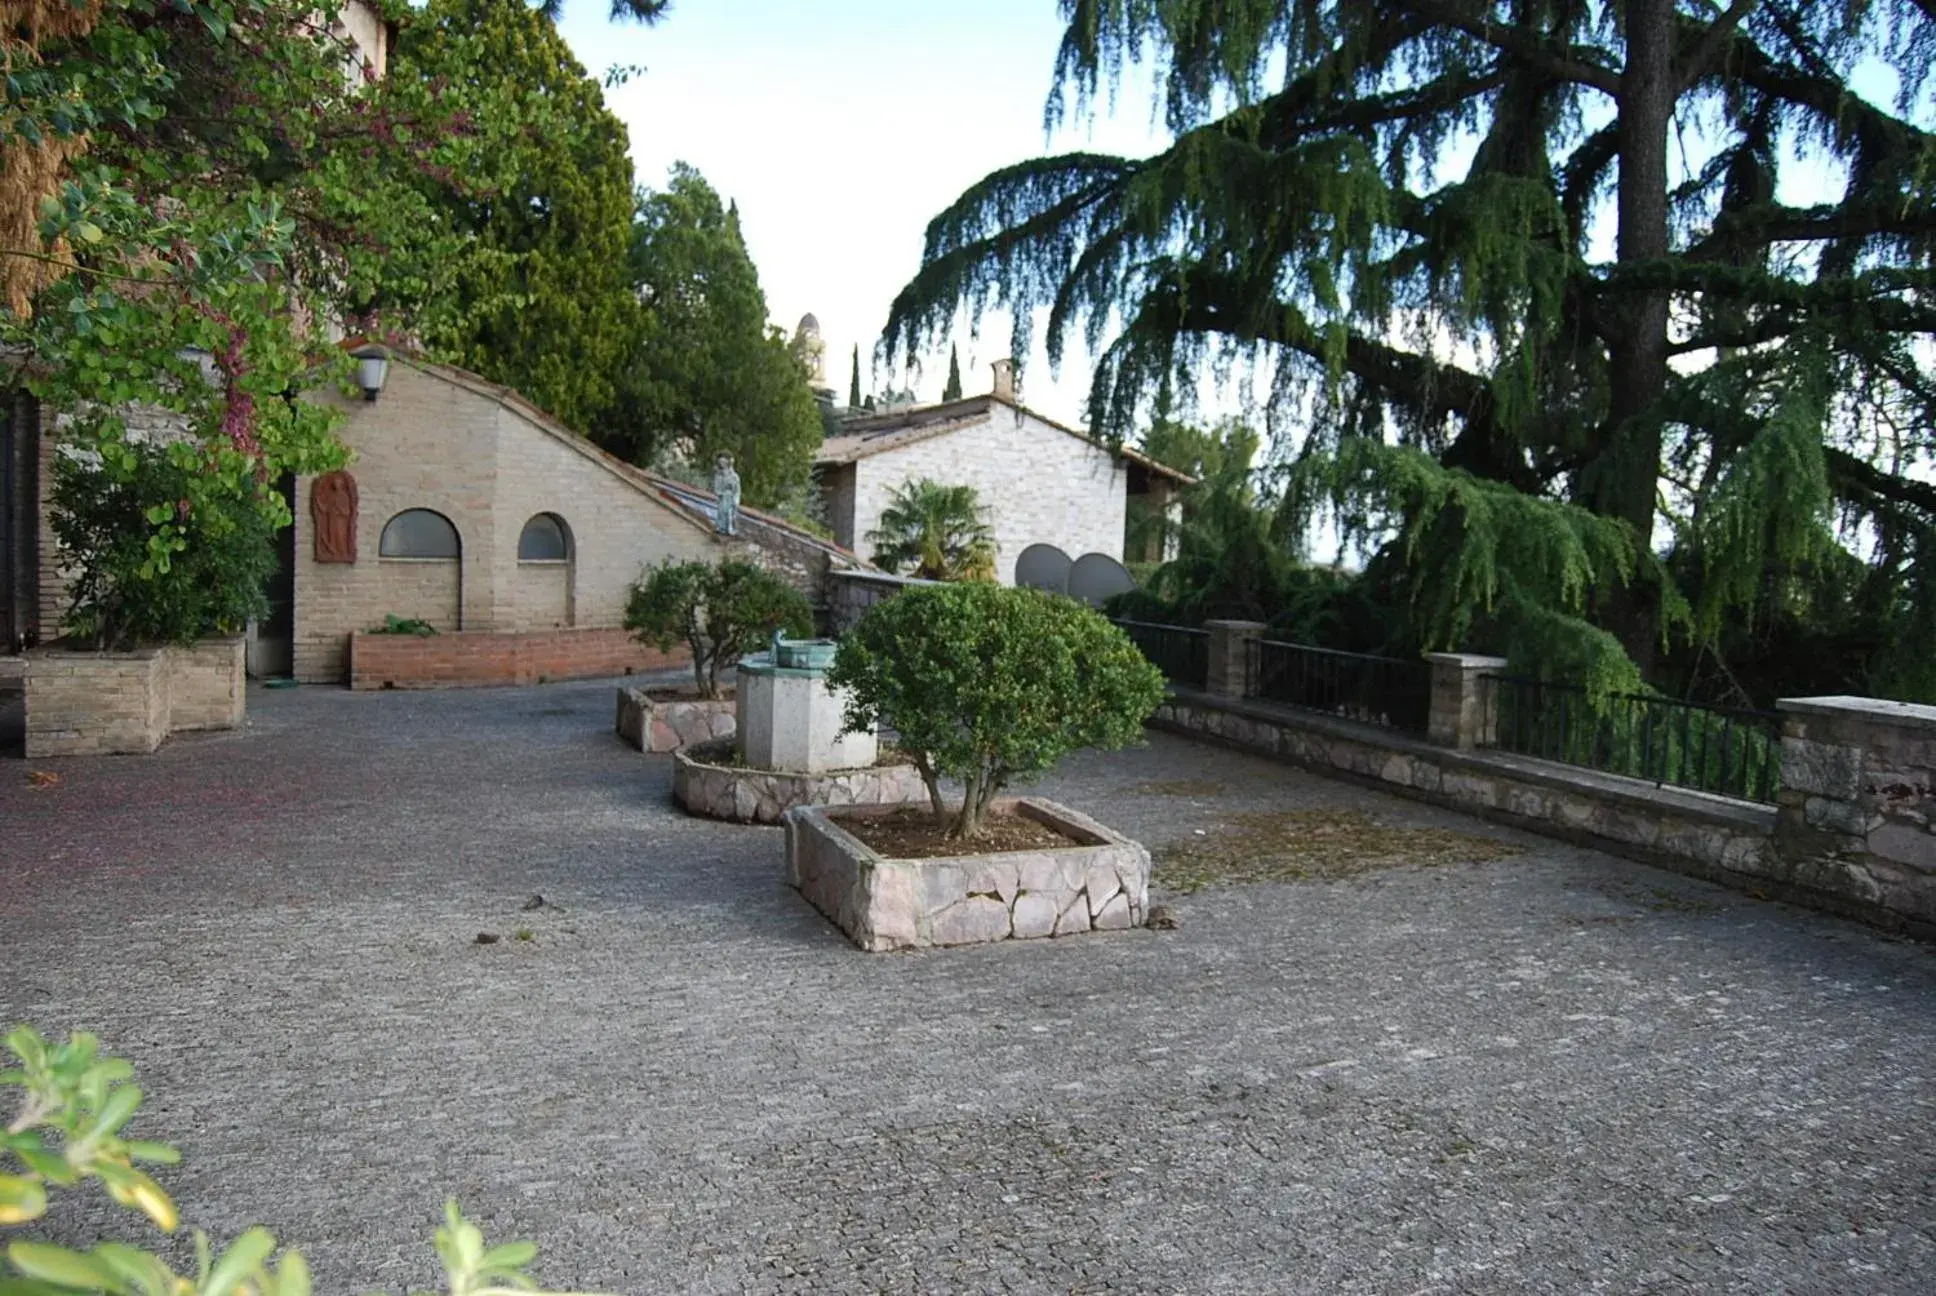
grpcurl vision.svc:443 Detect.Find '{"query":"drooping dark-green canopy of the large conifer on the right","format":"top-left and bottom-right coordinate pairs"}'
top-left (885, 0), bottom-right (1936, 699)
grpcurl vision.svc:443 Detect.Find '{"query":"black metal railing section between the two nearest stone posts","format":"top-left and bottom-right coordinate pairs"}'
top-left (1479, 676), bottom-right (1781, 804)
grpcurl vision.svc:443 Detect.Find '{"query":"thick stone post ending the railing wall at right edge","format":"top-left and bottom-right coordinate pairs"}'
top-left (1775, 697), bottom-right (1936, 928)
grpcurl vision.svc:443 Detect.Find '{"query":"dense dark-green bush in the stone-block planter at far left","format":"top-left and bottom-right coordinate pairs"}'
top-left (52, 444), bottom-right (288, 649)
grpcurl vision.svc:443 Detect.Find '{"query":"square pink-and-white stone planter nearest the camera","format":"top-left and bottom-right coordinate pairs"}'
top-left (786, 796), bottom-right (1150, 951)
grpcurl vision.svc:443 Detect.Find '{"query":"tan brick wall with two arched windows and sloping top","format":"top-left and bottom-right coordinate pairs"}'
top-left (294, 362), bottom-right (720, 682)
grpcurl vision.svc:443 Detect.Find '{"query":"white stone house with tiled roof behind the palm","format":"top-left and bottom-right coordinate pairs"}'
top-left (815, 360), bottom-right (1191, 585)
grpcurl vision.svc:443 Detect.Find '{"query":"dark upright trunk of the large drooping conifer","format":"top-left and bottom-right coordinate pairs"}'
top-left (1582, 0), bottom-right (1675, 664)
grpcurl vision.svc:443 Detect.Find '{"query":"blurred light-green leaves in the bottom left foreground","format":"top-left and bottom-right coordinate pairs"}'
top-left (0, 1027), bottom-right (588, 1296)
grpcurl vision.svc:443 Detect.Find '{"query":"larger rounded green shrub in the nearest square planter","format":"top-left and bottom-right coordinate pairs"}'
top-left (827, 583), bottom-right (1164, 839)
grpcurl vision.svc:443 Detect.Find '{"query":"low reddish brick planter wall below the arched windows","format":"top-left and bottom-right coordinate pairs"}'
top-left (350, 630), bottom-right (691, 690)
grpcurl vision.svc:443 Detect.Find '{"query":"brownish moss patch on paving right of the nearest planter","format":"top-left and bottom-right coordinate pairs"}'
top-left (1152, 810), bottom-right (1520, 891)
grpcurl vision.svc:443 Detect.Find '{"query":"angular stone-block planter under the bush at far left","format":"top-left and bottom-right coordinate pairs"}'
top-left (25, 637), bottom-right (248, 757)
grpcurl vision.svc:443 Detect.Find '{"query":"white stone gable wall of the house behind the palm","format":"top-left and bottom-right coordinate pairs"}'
top-left (834, 403), bottom-right (1129, 585)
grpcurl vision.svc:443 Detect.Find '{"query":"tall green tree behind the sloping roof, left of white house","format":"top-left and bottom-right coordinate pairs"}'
top-left (611, 163), bottom-right (821, 508)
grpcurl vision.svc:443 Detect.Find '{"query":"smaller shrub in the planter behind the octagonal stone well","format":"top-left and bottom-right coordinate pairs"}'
top-left (625, 558), bottom-right (813, 697)
